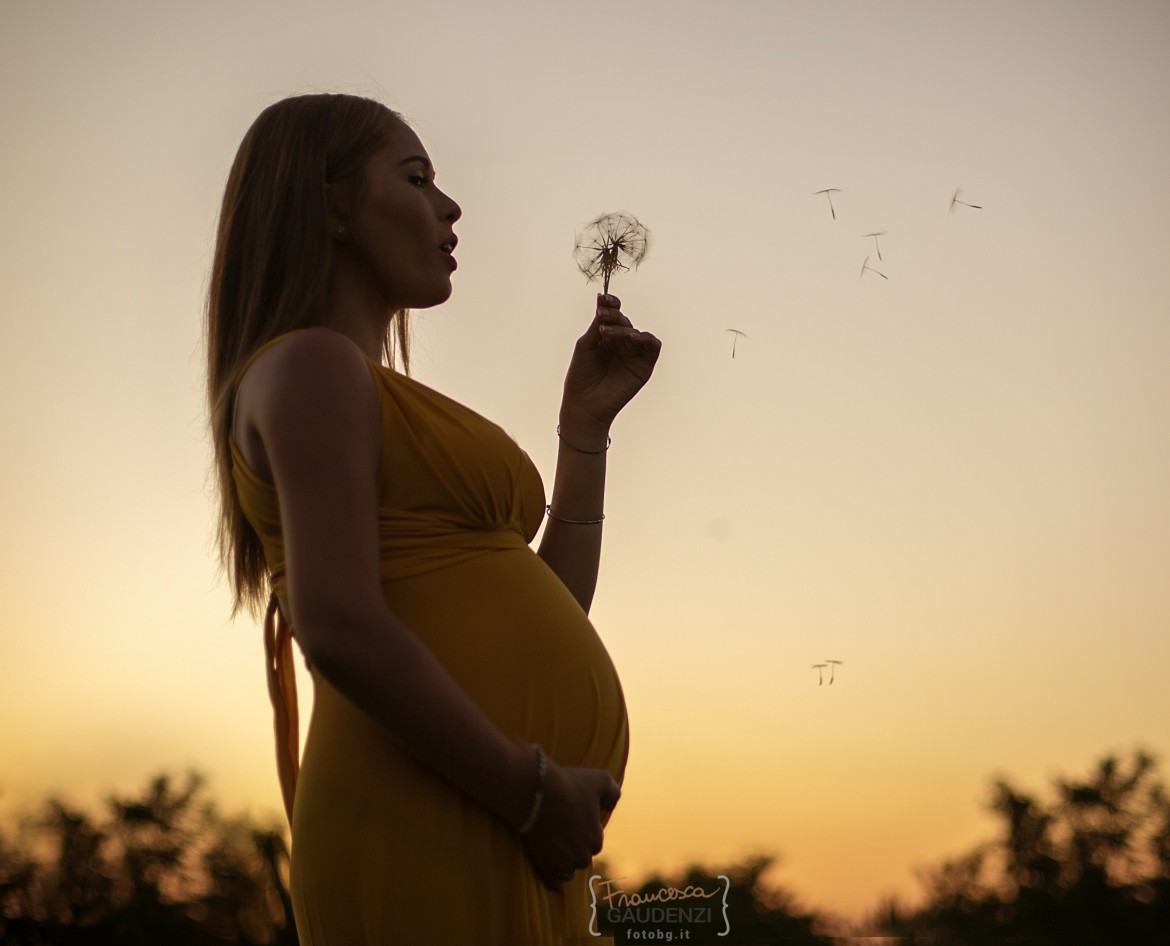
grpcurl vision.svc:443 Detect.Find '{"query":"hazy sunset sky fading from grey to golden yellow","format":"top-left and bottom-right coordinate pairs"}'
top-left (0, 0), bottom-right (1170, 914)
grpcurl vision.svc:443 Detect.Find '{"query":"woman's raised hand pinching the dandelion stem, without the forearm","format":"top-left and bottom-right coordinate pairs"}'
top-left (560, 294), bottom-right (662, 433)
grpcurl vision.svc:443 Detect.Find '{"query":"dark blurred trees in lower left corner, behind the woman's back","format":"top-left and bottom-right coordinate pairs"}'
top-left (0, 773), bottom-right (297, 946)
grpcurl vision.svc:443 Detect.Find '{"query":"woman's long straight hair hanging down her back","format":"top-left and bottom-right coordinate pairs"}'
top-left (206, 94), bottom-right (410, 617)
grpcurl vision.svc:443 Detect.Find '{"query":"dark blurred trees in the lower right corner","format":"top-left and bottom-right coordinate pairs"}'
top-left (875, 751), bottom-right (1170, 946)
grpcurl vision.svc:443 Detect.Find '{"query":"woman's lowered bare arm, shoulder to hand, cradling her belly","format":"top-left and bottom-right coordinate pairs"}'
top-left (239, 330), bottom-right (618, 872)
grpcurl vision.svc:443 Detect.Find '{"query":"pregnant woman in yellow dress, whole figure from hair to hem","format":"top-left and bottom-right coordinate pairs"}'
top-left (207, 95), bottom-right (661, 946)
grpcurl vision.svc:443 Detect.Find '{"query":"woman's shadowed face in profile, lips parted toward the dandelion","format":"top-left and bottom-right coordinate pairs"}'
top-left (345, 122), bottom-right (462, 309)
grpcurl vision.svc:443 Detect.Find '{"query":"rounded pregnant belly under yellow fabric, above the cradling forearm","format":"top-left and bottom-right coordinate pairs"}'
top-left (372, 548), bottom-right (628, 782)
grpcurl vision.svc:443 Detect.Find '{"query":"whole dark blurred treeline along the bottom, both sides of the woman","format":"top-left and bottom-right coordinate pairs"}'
top-left (0, 751), bottom-right (1170, 946)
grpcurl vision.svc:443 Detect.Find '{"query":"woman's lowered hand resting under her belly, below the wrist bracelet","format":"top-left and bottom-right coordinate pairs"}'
top-left (523, 759), bottom-right (621, 890)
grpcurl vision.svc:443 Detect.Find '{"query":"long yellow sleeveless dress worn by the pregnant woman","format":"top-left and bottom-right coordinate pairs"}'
top-left (230, 333), bottom-right (629, 946)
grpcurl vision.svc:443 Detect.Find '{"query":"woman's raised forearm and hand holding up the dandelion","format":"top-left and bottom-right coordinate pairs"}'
top-left (538, 294), bottom-right (662, 612)
